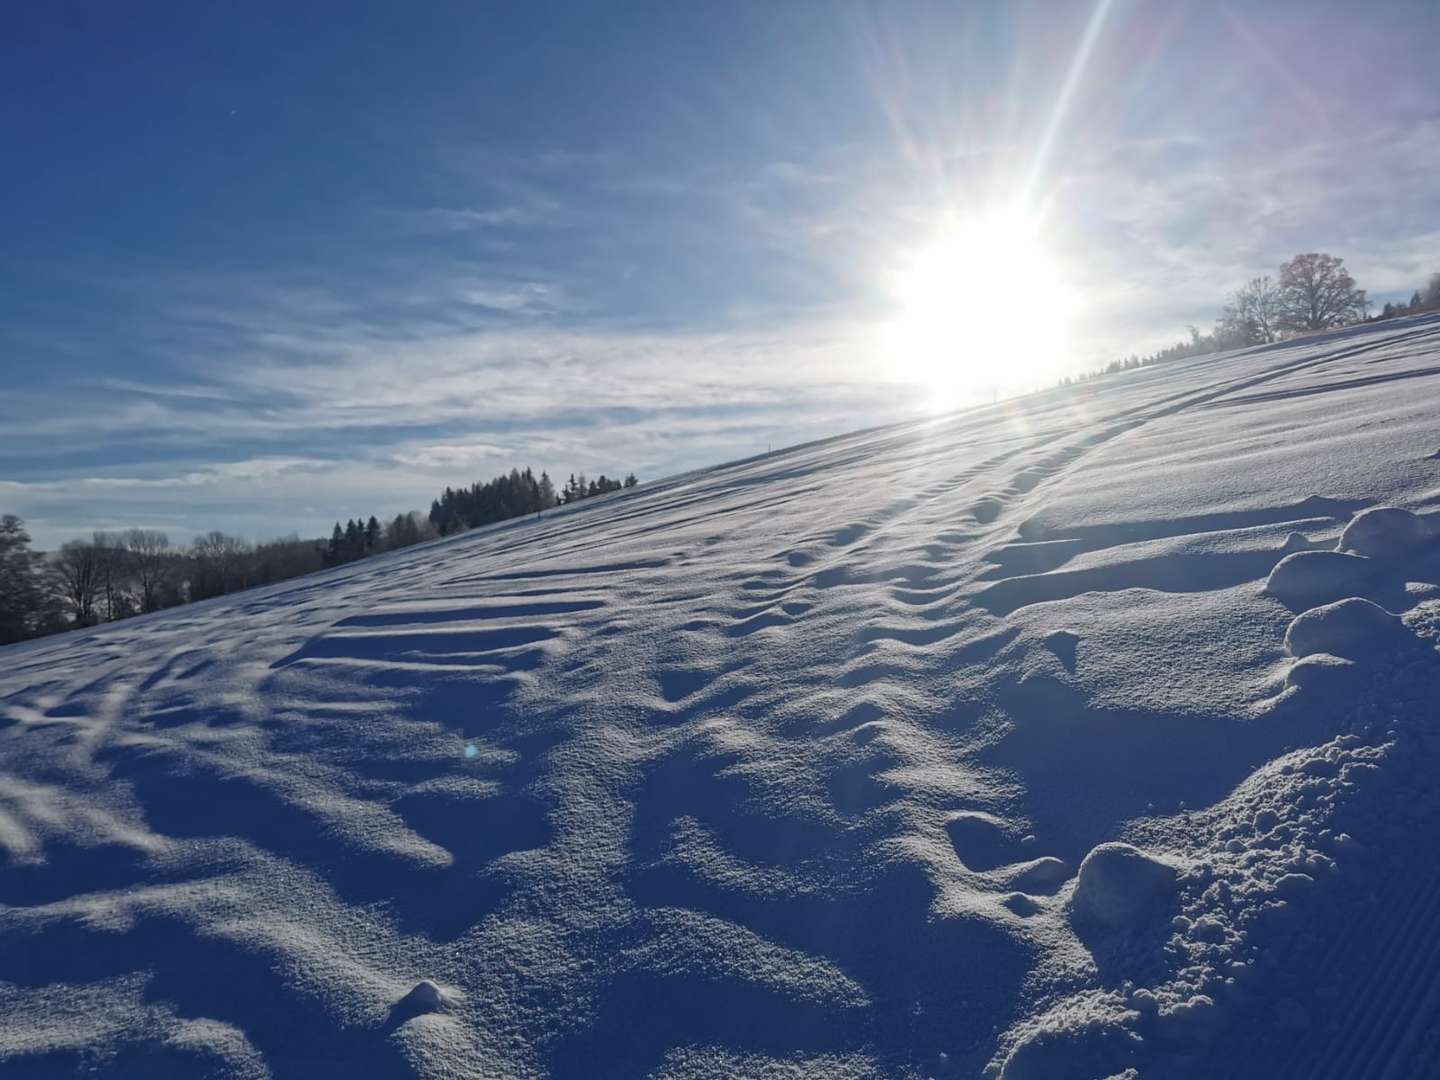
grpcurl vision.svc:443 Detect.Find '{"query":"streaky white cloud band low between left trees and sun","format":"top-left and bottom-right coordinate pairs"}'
top-left (0, 260), bottom-right (914, 544)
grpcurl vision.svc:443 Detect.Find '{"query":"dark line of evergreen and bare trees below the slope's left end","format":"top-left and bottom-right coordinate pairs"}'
top-left (0, 468), bottom-right (639, 645)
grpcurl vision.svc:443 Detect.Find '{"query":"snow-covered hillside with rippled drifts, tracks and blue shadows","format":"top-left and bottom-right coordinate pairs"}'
top-left (0, 320), bottom-right (1440, 1080)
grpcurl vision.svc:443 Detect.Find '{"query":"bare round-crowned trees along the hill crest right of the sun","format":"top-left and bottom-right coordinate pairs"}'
top-left (1060, 252), bottom-right (1440, 386)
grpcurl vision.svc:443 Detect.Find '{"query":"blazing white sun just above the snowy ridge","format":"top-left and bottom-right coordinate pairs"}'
top-left (881, 206), bottom-right (1074, 408)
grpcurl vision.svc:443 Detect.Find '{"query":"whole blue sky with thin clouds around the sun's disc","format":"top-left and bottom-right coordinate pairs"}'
top-left (0, 0), bottom-right (1440, 546)
